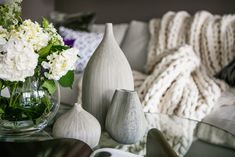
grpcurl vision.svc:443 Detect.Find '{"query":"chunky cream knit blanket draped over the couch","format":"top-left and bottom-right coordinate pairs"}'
top-left (134, 11), bottom-right (235, 120)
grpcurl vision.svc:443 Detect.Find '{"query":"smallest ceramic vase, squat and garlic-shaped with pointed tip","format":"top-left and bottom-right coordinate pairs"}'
top-left (52, 103), bottom-right (101, 148)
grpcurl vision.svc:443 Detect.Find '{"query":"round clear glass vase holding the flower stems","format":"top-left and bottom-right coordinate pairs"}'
top-left (0, 77), bottom-right (60, 136)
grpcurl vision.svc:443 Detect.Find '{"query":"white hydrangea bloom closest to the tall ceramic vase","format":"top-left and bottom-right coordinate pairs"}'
top-left (42, 48), bottom-right (78, 80)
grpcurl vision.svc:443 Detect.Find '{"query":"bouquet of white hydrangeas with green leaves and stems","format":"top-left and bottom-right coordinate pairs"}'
top-left (0, 0), bottom-right (78, 121)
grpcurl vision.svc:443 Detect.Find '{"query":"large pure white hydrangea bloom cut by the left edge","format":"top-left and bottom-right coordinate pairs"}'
top-left (0, 38), bottom-right (38, 81)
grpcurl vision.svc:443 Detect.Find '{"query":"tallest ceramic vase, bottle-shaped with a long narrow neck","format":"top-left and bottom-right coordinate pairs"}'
top-left (82, 23), bottom-right (134, 129)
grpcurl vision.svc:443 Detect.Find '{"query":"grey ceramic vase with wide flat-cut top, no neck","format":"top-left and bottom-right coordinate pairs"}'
top-left (105, 90), bottom-right (147, 144)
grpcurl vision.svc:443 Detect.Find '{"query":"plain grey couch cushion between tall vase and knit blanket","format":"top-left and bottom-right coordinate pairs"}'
top-left (121, 21), bottom-right (149, 72)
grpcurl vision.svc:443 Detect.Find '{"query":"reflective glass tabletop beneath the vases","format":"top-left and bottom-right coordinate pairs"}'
top-left (2, 110), bottom-right (235, 157)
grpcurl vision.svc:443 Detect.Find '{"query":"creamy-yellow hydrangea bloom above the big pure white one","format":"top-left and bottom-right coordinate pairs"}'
top-left (11, 20), bottom-right (50, 51)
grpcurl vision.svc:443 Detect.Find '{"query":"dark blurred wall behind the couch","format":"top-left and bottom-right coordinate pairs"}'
top-left (23, 0), bottom-right (235, 23)
